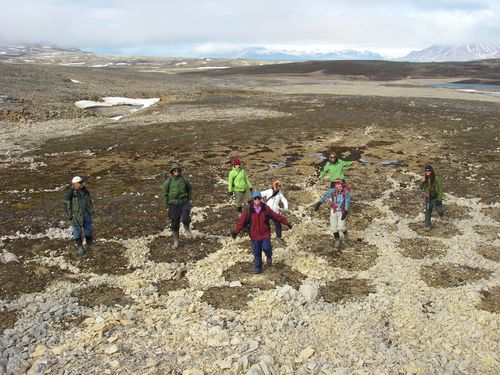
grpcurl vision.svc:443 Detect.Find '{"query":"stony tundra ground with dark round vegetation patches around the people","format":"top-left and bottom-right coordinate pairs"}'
top-left (0, 56), bottom-right (500, 375)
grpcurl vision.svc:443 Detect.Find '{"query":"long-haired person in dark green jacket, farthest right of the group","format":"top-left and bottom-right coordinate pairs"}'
top-left (419, 165), bottom-right (444, 230)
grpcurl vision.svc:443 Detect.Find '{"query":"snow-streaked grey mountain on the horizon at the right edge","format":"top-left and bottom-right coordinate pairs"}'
top-left (400, 43), bottom-right (500, 61)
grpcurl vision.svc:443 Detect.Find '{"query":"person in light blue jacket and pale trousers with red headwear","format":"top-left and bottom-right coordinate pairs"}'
top-left (330, 178), bottom-right (351, 247)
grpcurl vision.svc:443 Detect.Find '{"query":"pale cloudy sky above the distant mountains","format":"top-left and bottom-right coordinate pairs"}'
top-left (0, 0), bottom-right (500, 57)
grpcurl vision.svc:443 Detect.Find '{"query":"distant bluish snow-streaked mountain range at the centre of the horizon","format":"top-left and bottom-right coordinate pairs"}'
top-left (235, 47), bottom-right (384, 61)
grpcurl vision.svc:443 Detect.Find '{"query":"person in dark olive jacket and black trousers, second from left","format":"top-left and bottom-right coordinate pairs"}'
top-left (161, 163), bottom-right (192, 249)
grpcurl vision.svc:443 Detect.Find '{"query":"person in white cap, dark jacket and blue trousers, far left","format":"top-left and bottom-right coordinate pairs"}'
top-left (64, 176), bottom-right (94, 257)
